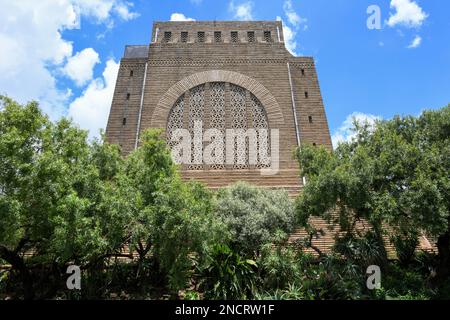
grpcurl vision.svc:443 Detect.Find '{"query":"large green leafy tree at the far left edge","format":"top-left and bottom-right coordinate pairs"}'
top-left (0, 97), bottom-right (128, 299)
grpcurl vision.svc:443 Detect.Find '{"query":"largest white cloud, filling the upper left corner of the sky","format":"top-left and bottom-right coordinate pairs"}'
top-left (0, 0), bottom-right (137, 119)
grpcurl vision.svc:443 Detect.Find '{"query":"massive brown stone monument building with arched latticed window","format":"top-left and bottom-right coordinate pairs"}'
top-left (106, 21), bottom-right (332, 195)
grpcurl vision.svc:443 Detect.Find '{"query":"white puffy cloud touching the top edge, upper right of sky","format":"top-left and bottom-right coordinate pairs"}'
top-left (387, 0), bottom-right (428, 28)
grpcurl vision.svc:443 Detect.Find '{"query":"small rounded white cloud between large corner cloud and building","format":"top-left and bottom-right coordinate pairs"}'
top-left (63, 48), bottom-right (100, 87)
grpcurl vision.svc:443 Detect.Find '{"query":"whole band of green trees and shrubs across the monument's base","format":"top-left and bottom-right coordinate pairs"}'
top-left (0, 97), bottom-right (450, 299)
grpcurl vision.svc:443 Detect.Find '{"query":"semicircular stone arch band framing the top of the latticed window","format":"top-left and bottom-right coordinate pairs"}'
top-left (150, 70), bottom-right (284, 129)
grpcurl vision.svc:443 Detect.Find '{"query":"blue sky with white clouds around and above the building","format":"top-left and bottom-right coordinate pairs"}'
top-left (0, 0), bottom-right (450, 146)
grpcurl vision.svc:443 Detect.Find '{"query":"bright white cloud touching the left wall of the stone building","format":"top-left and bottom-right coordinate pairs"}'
top-left (68, 60), bottom-right (119, 138)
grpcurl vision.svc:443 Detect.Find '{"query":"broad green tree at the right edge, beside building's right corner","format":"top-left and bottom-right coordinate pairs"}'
top-left (296, 106), bottom-right (450, 277)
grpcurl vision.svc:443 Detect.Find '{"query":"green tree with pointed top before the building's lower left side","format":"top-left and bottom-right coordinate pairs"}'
top-left (121, 129), bottom-right (221, 290)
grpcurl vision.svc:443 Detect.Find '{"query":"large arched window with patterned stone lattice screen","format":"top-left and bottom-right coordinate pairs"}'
top-left (167, 82), bottom-right (270, 170)
